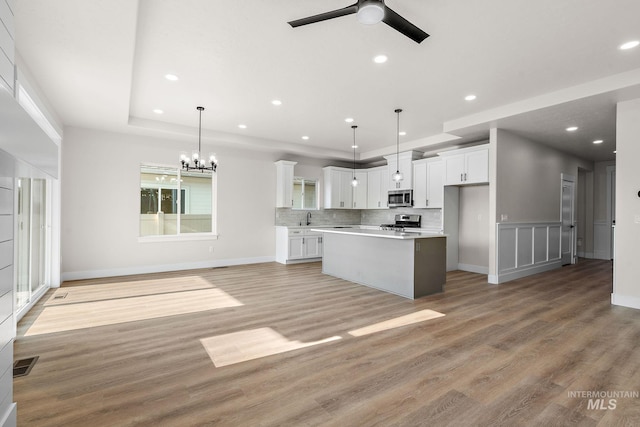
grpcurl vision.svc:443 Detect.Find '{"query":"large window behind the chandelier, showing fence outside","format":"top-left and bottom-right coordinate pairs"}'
top-left (140, 165), bottom-right (215, 237)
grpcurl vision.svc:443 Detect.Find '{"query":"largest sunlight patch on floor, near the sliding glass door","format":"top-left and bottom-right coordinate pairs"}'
top-left (24, 288), bottom-right (243, 336)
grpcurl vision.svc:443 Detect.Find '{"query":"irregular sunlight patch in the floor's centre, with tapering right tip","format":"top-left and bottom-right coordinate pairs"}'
top-left (200, 328), bottom-right (341, 368)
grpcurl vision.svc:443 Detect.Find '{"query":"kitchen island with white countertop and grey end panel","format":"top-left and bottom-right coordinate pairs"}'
top-left (313, 228), bottom-right (447, 299)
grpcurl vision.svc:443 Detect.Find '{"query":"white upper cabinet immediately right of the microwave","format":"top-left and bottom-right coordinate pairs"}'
top-left (413, 158), bottom-right (444, 208)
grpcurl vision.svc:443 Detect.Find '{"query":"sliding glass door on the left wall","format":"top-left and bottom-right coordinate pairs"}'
top-left (16, 178), bottom-right (47, 312)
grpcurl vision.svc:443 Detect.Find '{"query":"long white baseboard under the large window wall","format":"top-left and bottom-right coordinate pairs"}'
top-left (62, 256), bottom-right (275, 282)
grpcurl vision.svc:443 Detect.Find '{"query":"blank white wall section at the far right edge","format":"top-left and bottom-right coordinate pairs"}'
top-left (611, 99), bottom-right (640, 309)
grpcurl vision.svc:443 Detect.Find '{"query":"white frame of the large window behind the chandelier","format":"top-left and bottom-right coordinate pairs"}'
top-left (136, 162), bottom-right (218, 243)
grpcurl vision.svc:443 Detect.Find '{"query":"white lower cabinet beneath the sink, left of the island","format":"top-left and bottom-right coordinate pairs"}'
top-left (276, 227), bottom-right (322, 264)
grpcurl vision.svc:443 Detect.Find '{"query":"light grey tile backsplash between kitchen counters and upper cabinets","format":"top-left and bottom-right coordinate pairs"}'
top-left (275, 208), bottom-right (442, 229)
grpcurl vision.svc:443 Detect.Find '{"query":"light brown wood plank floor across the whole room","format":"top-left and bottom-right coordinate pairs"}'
top-left (14, 260), bottom-right (640, 427)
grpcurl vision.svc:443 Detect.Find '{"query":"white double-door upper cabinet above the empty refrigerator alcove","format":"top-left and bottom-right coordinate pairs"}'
top-left (439, 144), bottom-right (489, 185)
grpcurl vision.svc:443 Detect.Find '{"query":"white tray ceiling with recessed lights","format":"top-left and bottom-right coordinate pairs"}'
top-left (11, 0), bottom-right (640, 161)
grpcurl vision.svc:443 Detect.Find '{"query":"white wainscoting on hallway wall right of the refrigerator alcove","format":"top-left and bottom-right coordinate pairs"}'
top-left (491, 222), bottom-right (562, 283)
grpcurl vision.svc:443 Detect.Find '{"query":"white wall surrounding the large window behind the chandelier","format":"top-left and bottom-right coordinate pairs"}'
top-left (62, 128), bottom-right (278, 280)
